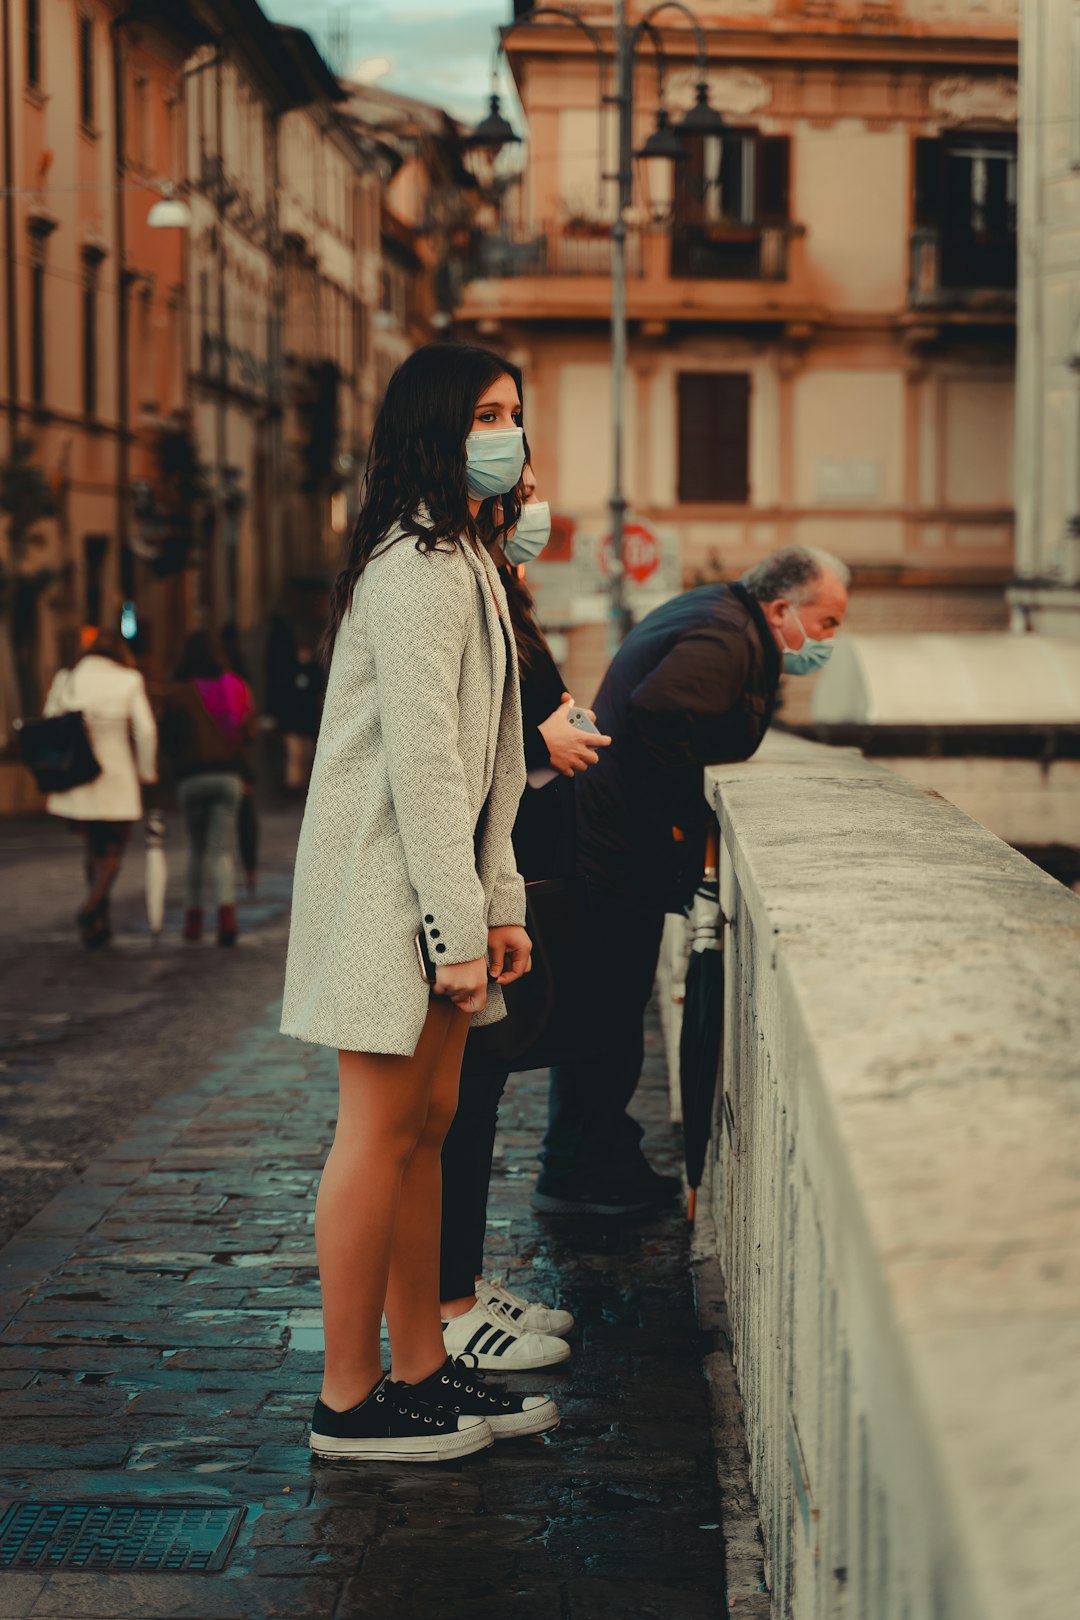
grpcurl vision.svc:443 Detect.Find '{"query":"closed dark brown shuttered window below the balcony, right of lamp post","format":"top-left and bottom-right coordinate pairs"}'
top-left (678, 371), bottom-right (750, 505)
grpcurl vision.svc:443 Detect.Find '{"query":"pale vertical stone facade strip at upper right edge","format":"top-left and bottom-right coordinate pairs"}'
top-left (1010, 0), bottom-right (1080, 637)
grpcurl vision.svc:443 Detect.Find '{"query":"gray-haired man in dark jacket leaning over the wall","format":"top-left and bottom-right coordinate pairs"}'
top-left (533, 546), bottom-right (848, 1215)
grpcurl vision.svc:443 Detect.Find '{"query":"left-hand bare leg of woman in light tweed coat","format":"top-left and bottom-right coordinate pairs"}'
top-left (316, 1000), bottom-right (466, 1411)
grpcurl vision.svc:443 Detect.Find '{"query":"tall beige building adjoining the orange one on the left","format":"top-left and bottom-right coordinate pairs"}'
top-left (166, 0), bottom-right (386, 677)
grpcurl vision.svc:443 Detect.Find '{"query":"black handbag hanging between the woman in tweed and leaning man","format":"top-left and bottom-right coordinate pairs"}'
top-left (468, 878), bottom-right (586, 1069)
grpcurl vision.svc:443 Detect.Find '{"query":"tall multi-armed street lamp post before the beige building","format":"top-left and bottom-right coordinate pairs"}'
top-left (473, 0), bottom-right (725, 654)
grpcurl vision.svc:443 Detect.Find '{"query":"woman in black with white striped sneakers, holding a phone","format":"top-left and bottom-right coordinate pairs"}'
top-left (439, 467), bottom-right (610, 1372)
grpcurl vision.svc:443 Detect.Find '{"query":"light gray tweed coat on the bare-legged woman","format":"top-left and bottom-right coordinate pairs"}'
top-left (282, 530), bottom-right (525, 1056)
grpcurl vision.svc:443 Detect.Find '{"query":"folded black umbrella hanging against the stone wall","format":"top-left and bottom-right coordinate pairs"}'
top-left (678, 847), bottom-right (724, 1220)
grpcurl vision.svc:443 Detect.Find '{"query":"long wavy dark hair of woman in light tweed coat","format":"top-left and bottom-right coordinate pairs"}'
top-left (321, 343), bottom-right (528, 663)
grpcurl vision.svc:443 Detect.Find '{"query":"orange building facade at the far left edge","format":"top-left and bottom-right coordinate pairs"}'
top-left (0, 0), bottom-right (207, 810)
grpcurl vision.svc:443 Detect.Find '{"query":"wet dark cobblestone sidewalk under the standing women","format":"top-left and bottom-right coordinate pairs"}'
top-left (0, 1009), bottom-right (724, 1620)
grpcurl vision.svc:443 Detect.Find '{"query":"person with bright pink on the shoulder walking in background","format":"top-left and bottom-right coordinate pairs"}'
top-left (162, 630), bottom-right (254, 946)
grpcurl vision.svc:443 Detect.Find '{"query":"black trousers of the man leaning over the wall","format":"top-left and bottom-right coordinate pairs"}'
top-left (541, 888), bottom-right (664, 1187)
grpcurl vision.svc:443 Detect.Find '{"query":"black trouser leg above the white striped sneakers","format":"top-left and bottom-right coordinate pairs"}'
top-left (439, 1043), bottom-right (510, 1299)
